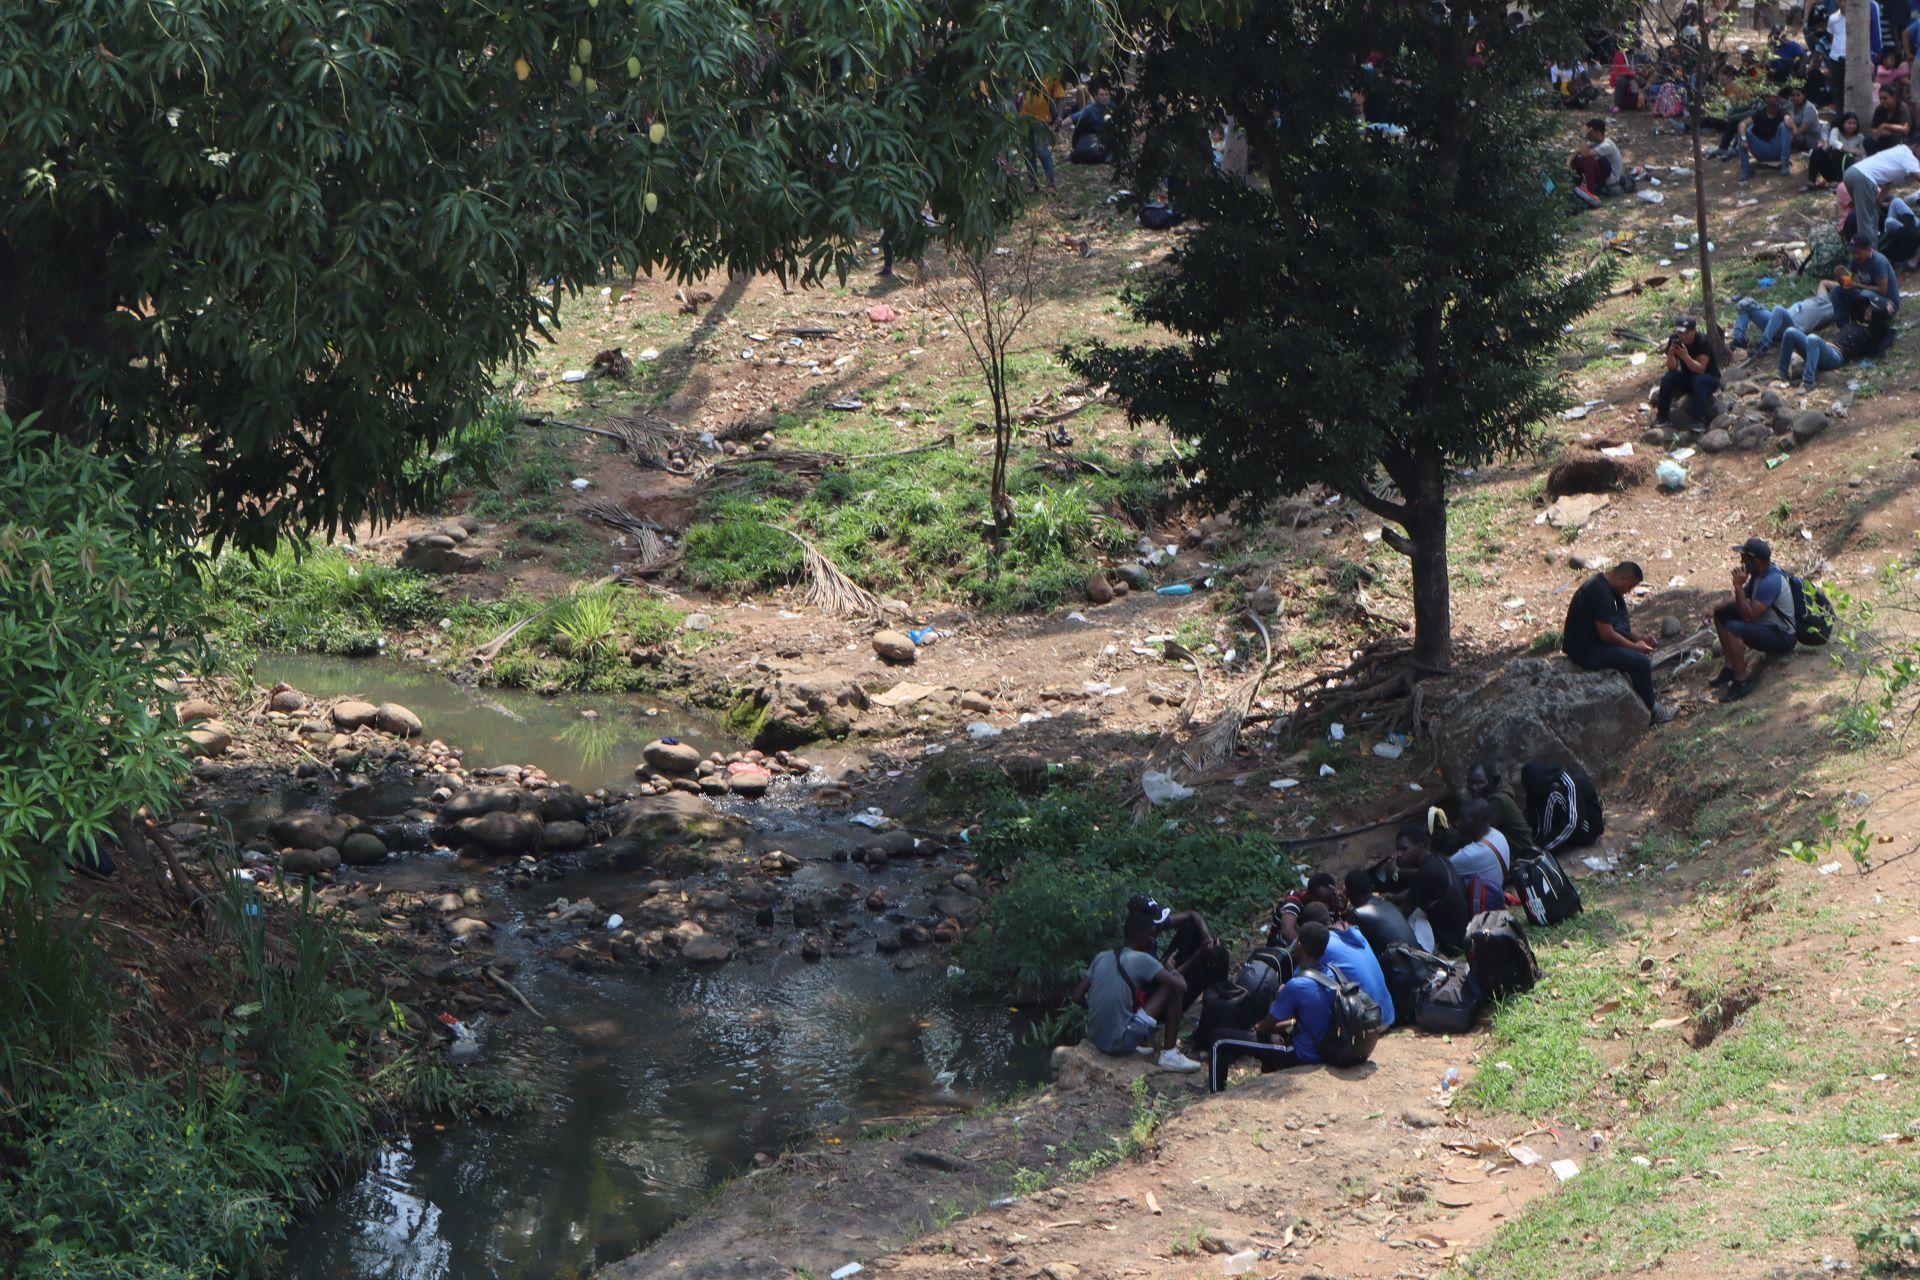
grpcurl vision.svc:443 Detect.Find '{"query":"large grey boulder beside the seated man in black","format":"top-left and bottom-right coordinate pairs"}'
top-left (1434, 658), bottom-right (1647, 787)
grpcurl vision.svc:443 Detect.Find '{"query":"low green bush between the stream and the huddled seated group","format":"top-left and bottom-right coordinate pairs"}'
top-left (962, 793), bottom-right (1296, 998)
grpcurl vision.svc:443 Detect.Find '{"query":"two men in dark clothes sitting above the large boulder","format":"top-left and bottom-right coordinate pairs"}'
top-left (1561, 537), bottom-right (1799, 723)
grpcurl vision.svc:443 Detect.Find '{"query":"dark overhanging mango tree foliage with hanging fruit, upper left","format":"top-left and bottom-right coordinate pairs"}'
top-left (0, 0), bottom-right (1102, 547)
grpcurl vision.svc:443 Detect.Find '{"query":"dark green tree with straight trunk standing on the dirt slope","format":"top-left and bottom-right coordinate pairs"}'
top-left (1073, 0), bottom-right (1601, 664)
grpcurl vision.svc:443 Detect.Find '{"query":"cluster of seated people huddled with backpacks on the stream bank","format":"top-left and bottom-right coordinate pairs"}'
top-left (1073, 762), bottom-right (1605, 1092)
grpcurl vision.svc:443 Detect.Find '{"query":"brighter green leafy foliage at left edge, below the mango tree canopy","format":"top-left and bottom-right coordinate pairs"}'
top-left (0, 415), bottom-right (186, 898)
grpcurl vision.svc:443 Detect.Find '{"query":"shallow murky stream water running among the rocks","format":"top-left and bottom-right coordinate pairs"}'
top-left (245, 654), bottom-right (1046, 1280)
